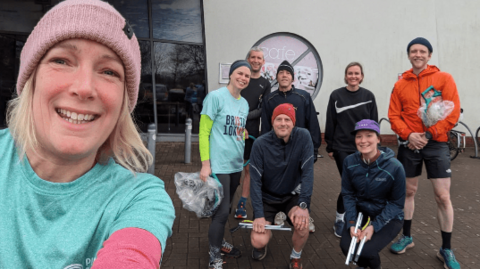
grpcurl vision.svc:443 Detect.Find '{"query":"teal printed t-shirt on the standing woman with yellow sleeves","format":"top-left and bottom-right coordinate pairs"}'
top-left (201, 87), bottom-right (248, 174)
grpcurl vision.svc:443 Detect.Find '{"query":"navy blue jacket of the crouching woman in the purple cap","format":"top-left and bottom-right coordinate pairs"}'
top-left (342, 147), bottom-right (405, 232)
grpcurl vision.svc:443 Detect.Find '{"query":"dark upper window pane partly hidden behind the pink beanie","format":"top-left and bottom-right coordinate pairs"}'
top-left (108, 0), bottom-right (150, 38)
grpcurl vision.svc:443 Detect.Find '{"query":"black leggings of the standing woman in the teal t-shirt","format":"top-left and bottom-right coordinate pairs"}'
top-left (208, 171), bottom-right (242, 255)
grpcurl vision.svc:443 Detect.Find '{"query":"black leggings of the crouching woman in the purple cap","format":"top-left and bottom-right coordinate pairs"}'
top-left (340, 219), bottom-right (403, 269)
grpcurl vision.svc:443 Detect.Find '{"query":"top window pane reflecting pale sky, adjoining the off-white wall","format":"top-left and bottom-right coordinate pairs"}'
top-left (152, 0), bottom-right (203, 43)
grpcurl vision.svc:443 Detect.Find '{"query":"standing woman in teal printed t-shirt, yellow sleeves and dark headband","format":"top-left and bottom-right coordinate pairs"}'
top-left (198, 60), bottom-right (251, 269)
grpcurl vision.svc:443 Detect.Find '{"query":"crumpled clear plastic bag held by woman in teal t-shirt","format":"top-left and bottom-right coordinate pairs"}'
top-left (174, 172), bottom-right (223, 218)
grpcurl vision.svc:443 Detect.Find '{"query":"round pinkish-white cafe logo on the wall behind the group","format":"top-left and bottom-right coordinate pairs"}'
top-left (255, 33), bottom-right (323, 99)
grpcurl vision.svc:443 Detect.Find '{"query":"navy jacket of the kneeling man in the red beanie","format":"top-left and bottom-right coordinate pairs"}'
top-left (250, 127), bottom-right (313, 218)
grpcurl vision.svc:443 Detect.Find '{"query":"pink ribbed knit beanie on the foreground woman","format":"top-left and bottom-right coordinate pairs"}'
top-left (17, 0), bottom-right (141, 112)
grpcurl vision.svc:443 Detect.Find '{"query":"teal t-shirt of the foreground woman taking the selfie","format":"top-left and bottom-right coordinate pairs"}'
top-left (0, 129), bottom-right (175, 269)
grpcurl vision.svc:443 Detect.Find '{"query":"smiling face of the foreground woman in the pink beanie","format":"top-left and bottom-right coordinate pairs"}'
top-left (33, 39), bottom-right (125, 161)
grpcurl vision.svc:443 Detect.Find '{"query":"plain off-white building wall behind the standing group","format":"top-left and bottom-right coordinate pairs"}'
top-left (203, 0), bottom-right (480, 134)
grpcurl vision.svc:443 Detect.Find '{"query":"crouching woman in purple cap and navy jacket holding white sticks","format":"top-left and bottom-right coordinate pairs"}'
top-left (340, 120), bottom-right (405, 269)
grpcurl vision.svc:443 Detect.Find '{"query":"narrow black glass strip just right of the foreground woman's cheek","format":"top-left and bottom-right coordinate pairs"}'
top-left (133, 41), bottom-right (155, 132)
